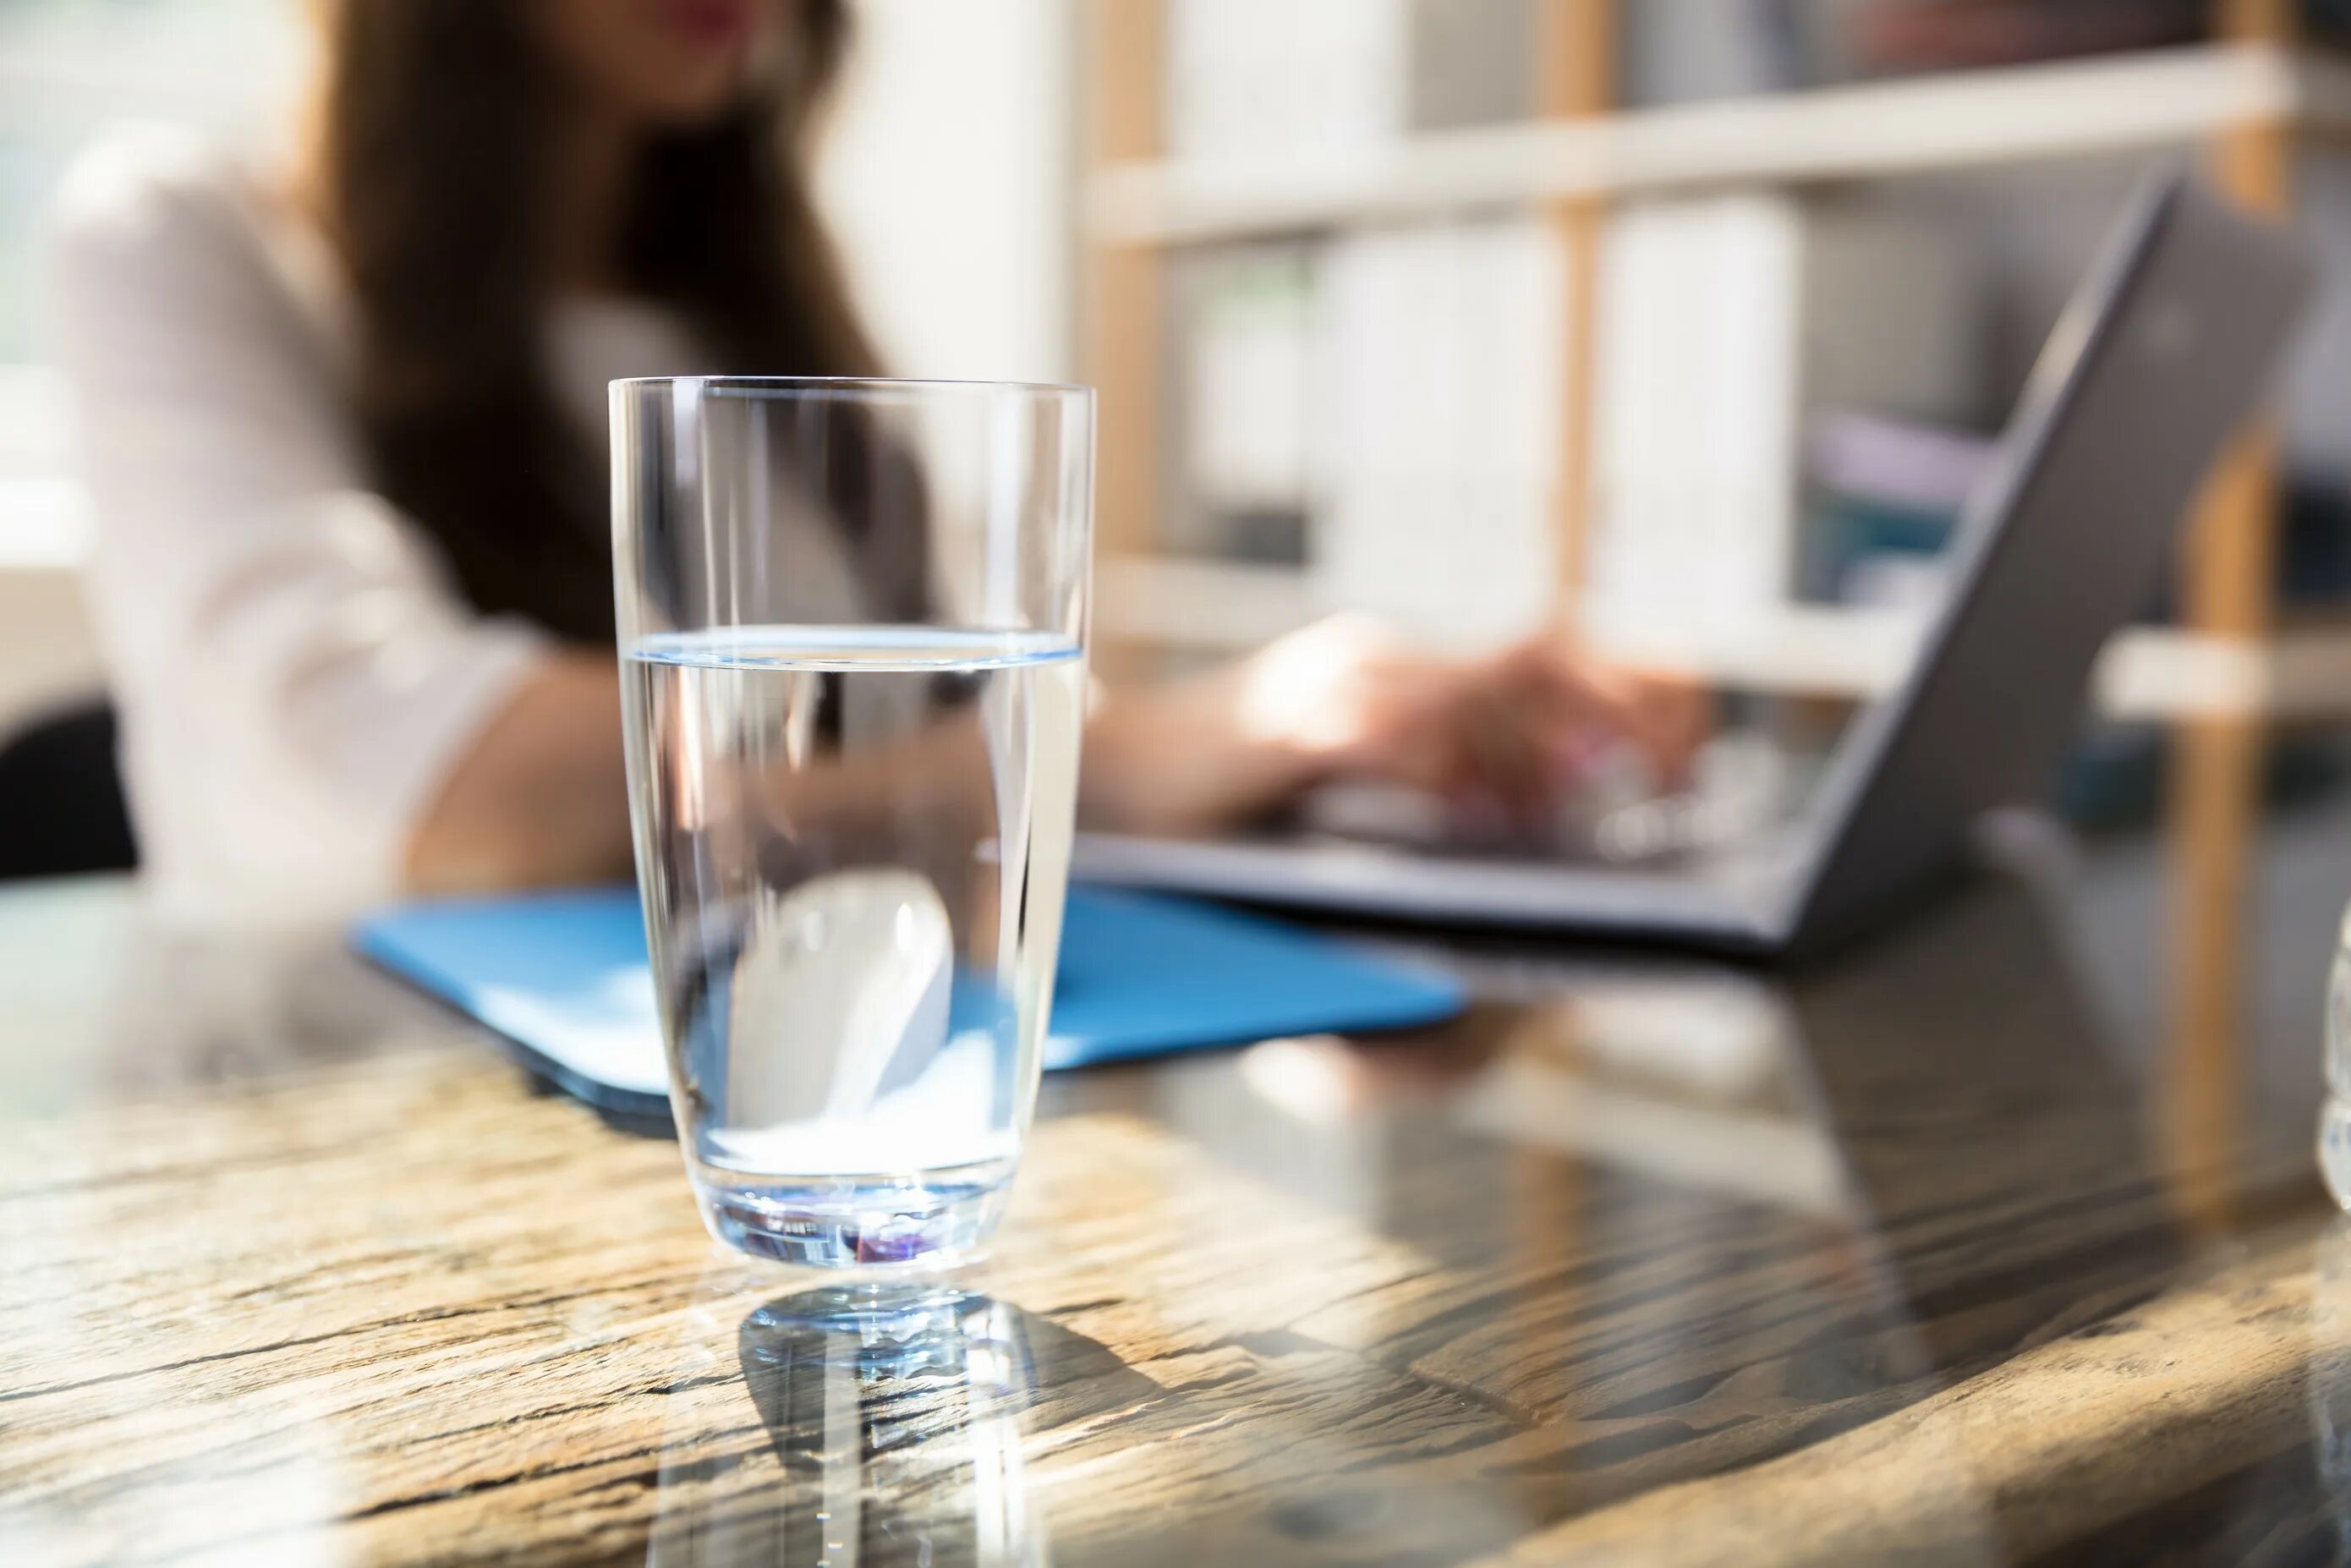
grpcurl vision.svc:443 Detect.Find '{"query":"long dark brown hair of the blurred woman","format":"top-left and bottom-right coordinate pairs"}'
top-left (310, 0), bottom-right (922, 644)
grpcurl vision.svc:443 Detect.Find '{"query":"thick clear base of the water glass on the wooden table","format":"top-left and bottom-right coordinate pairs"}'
top-left (696, 1171), bottom-right (1011, 1275)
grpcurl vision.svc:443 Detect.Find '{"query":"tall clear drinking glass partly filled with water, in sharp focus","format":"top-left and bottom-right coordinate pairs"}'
top-left (611, 376), bottom-right (1093, 1267)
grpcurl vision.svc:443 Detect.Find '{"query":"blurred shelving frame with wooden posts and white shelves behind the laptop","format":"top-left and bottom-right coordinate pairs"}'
top-left (1079, 0), bottom-right (2351, 717)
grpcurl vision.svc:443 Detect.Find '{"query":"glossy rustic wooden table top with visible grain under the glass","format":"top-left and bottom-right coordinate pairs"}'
top-left (0, 811), bottom-right (2351, 1565)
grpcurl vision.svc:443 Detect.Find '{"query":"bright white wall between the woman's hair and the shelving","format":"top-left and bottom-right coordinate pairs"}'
top-left (818, 0), bottom-right (1074, 381)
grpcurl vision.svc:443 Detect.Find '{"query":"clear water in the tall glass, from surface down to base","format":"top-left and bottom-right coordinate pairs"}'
top-left (623, 625), bottom-right (1084, 1267)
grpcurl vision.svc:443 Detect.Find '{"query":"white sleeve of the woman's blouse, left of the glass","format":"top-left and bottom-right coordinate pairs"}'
top-left (49, 144), bottom-right (543, 912)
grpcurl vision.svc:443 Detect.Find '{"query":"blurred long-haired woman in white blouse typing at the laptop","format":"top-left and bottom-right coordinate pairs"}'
top-left (57, 0), bottom-right (1664, 914)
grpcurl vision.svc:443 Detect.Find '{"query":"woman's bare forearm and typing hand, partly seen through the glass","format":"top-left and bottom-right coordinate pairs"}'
top-left (407, 621), bottom-right (1697, 893)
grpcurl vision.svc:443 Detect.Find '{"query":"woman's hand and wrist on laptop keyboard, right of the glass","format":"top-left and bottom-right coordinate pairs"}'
top-left (1079, 618), bottom-right (1707, 835)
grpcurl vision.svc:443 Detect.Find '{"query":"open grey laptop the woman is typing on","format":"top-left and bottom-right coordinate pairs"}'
top-left (1077, 174), bottom-right (2311, 955)
